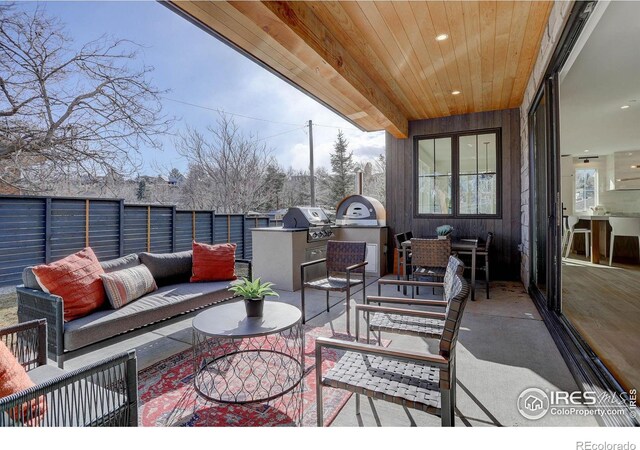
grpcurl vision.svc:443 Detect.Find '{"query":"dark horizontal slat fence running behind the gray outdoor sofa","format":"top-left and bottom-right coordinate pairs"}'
top-left (0, 196), bottom-right (273, 287)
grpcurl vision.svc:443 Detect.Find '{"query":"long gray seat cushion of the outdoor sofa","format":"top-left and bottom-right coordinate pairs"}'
top-left (64, 281), bottom-right (233, 351)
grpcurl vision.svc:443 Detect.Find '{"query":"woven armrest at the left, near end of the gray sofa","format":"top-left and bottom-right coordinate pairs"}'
top-left (16, 286), bottom-right (64, 368)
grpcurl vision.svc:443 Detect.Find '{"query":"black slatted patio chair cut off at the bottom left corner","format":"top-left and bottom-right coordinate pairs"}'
top-left (0, 319), bottom-right (138, 427)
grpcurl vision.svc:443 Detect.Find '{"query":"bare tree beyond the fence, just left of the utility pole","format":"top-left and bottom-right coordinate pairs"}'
top-left (176, 114), bottom-right (277, 213)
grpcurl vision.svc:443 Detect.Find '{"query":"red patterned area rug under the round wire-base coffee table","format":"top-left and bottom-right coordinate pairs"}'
top-left (138, 326), bottom-right (388, 427)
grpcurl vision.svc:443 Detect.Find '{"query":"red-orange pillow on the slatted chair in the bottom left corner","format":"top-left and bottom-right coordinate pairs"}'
top-left (0, 341), bottom-right (46, 425)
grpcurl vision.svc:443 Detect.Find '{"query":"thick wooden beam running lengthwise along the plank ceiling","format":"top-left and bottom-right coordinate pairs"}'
top-left (230, 1), bottom-right (409, 138)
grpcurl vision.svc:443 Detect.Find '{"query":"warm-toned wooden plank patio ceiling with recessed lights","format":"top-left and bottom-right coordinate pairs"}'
top-left (171, 0), bottom-right (553, 138)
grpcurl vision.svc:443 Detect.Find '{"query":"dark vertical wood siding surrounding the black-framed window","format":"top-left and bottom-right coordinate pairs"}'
top-left (386, 109), bottom-right (520, 280)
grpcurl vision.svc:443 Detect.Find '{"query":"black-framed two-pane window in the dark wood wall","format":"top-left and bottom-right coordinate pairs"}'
top-left (415, 129), bottom-right (500, 217)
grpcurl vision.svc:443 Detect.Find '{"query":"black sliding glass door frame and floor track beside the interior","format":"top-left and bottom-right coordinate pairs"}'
top-left (527, 0), bottom-right (640, 426)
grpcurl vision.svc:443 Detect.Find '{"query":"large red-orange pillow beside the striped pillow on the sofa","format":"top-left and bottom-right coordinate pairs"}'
top-left (33, 247), bottom-right (107, 322)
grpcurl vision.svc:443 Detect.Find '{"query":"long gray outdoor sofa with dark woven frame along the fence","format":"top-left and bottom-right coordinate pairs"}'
top-left (16, 250), bottom-right (251, 368)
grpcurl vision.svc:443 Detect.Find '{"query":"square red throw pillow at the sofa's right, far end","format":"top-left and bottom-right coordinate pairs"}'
top-left (191, 241), bottom-right (237, 282)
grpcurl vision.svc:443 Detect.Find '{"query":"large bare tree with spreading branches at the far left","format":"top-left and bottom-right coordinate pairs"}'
top-left (0, 5), bottom-right (171, 191)
